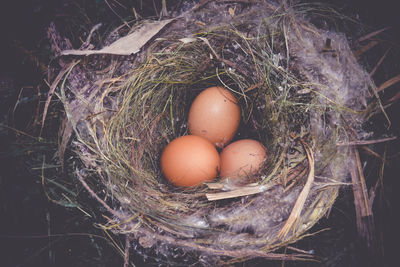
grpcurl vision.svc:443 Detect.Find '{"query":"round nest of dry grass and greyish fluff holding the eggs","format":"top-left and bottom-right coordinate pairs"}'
top-left (51, 1), bottom-right (372, 264)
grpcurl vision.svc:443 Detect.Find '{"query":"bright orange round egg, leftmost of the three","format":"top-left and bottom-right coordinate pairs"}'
top-left (161, 135), bottom-right (220, 186)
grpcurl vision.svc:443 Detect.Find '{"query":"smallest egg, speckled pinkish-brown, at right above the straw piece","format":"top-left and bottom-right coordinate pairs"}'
top-left (220, 139), bottom-right (267, 178)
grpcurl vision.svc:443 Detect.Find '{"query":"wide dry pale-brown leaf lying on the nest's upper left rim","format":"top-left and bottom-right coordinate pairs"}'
top-left (61, 19), bottom-right (174, 56)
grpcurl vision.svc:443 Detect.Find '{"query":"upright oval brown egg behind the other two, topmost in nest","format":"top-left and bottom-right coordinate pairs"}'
top-left (188, 86), bottom-right (240, 148)
